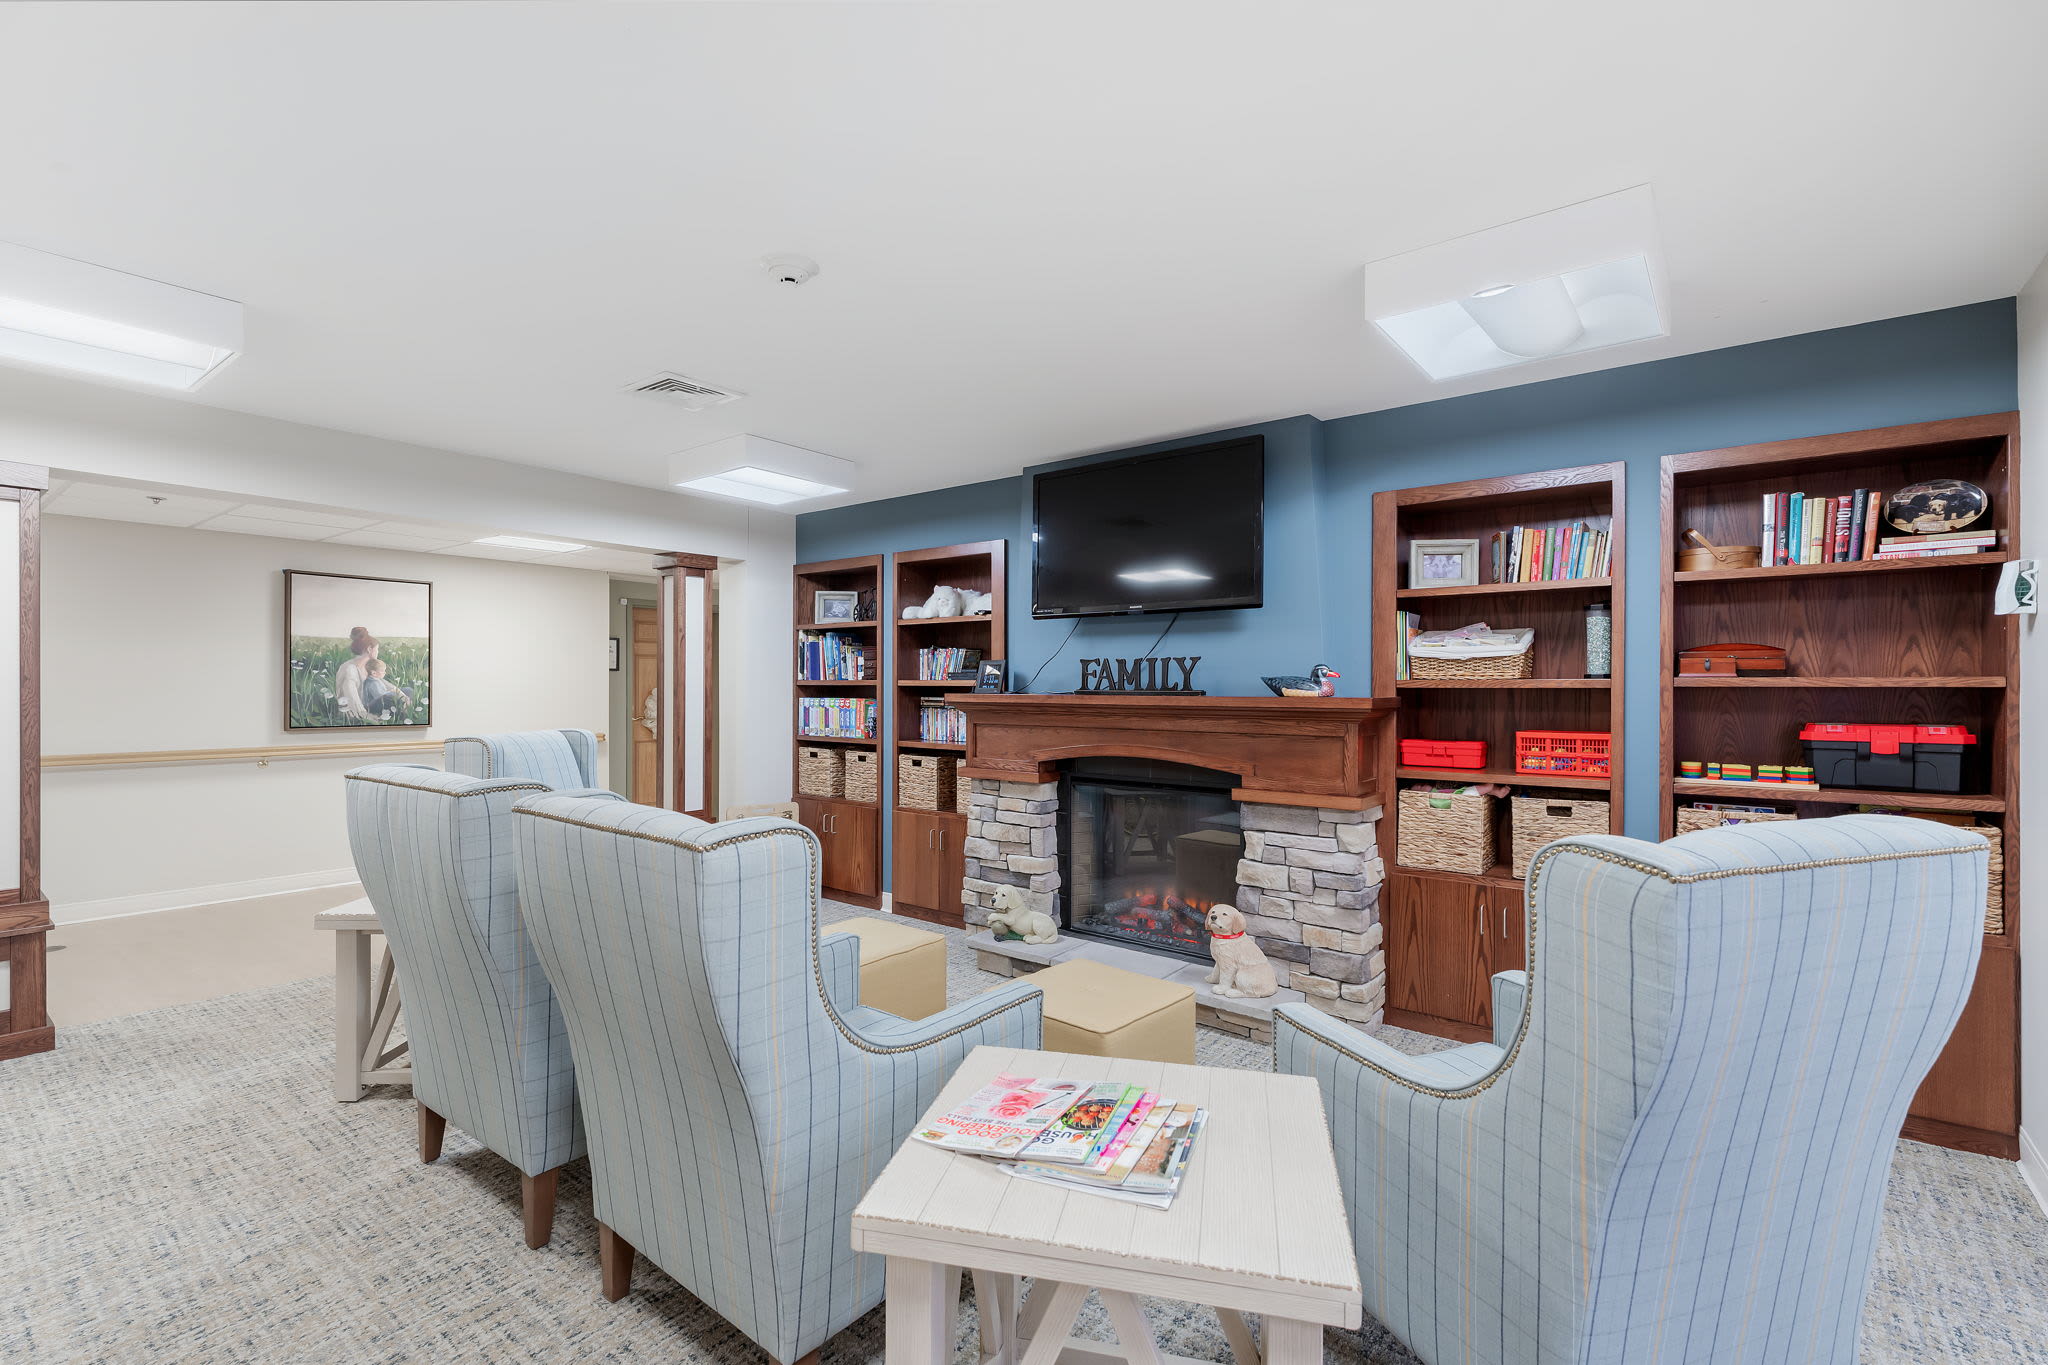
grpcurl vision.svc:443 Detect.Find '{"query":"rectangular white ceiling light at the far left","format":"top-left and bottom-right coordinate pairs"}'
top-left (0, 241), bottom-right (242, 389)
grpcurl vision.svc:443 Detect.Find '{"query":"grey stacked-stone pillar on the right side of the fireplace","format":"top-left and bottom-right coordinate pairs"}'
top-left (1237, 802), bottom-right (1386, 1023)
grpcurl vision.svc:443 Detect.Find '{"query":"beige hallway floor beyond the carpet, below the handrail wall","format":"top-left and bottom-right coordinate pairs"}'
top-left (49, 886), bottom-right (362, 1029)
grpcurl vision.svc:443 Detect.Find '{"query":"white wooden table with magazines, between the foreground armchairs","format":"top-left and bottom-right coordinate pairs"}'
top-left (852, 1048), bottom-right (1362, 1365)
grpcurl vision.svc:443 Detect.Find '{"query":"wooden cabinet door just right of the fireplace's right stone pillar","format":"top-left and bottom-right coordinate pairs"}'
top-left (1380, 872), bottom-right (1493, 1029)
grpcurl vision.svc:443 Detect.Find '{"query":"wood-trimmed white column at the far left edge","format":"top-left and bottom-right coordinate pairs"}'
top-left (0, 463), bottom-right (57, 1060)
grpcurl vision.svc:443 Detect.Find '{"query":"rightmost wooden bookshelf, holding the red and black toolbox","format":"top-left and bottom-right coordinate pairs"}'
top-left (1659, 413), bottom-right (2019, 1158)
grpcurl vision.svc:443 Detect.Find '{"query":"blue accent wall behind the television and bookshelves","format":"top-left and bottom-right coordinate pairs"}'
top-left (797, 299), bottom-right (2019, 875)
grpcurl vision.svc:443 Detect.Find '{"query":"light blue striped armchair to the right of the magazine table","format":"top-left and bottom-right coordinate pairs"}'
top-left (1276, 814), bottom-right (1987, 1365)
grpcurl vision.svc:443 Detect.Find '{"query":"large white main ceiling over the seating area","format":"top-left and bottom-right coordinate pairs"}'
top-left (0, 0), bottom-right (2048, 511)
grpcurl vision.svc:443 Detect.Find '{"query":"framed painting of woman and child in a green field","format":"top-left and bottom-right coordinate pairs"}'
top-left (285, 569), bottom-right (434, 731)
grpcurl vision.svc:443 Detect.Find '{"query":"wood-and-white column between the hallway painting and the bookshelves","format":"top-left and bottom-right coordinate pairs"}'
top-left (653, 553), bottom-right (719, 821)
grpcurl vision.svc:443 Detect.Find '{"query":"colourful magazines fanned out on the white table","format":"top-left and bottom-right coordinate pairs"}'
top-left (913, 1076), bottom-right (1208, 1209)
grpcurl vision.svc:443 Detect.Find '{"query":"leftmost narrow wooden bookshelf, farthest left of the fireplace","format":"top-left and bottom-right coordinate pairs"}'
top-left (791, 555), bottom-right (889, 909)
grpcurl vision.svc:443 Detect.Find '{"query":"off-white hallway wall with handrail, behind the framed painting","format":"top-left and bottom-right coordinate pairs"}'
top-left (43, 516), bottom-right (610, 923)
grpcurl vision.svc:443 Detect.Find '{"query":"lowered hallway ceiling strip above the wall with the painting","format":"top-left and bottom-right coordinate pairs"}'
top-left (43, 479), bottom-right (653, 579)
